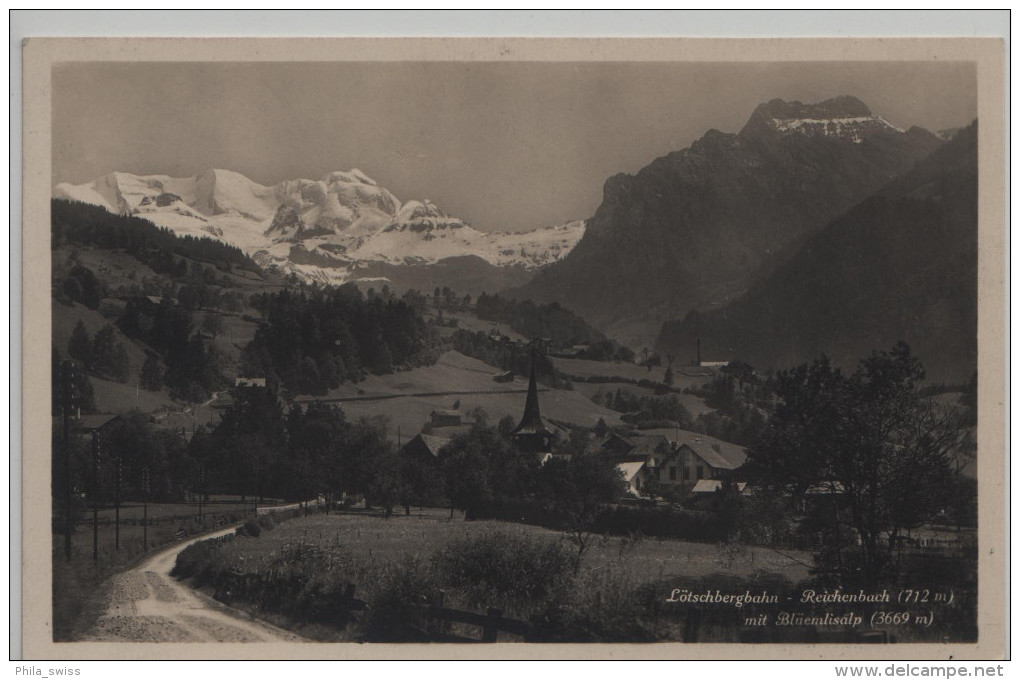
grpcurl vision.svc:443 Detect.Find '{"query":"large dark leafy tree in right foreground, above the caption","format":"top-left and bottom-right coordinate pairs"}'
top-left (749, 343), bottom-right (962, 587)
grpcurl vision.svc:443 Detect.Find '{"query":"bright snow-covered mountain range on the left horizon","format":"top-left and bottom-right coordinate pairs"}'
top-left (54, 169), bottom-right (584, 282)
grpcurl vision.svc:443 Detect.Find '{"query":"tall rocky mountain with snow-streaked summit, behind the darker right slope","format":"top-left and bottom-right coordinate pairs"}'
top-left (510, 97), bottom-right (941, 346)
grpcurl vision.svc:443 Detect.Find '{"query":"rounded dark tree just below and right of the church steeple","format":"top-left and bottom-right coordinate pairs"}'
top-left (539, 453), bottom-right (623, 573)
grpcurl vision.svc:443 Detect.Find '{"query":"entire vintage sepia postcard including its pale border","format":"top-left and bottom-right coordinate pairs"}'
top-left (22, 39), bottom-right (1008, 660)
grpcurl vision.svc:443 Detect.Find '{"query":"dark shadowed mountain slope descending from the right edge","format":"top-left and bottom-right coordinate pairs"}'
top-left (656, 123), bottom-right (977, 381)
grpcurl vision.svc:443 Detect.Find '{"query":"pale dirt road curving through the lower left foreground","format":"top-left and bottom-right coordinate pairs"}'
top-left (85, 515), bottom-right (302, 642)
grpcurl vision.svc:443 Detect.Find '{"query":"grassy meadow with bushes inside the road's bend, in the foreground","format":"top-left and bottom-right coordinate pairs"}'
top-left (175, 510), bottom-right (809, 641)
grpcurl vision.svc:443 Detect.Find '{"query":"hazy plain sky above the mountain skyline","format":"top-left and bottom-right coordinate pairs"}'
top-left (53, 62), bottom-right (977, 230)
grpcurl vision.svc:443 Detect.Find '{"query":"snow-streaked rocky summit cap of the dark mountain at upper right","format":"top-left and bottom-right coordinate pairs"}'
top-left (741, 95), bottom-right (903, 144)
